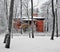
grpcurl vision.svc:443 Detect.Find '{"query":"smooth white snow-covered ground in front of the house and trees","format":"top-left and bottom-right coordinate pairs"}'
top-left (0, 35), bottom-right (60, 52)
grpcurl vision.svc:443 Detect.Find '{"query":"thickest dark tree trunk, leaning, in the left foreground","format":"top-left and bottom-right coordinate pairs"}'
top-left (5, 0), bottom-right (14, 48)
